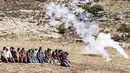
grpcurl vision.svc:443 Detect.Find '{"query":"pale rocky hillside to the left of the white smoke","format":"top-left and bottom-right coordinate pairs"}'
top-left (0, 0), bottom-right (61, 40)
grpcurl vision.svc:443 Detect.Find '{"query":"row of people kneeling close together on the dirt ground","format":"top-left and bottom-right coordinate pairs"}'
top-left (1, 47), bottom-right (70, 67)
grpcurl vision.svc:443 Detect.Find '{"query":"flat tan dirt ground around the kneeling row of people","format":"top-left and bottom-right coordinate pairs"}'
top-left (0, 41), bottom-right (130, 73)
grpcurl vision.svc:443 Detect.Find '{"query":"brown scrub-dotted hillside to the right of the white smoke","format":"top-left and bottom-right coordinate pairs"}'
top-left (96, 0), bottom-right (130, 42)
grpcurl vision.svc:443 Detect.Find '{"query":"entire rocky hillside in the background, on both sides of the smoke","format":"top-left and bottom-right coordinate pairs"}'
top-left (0, 0), bottom-right (130, 42)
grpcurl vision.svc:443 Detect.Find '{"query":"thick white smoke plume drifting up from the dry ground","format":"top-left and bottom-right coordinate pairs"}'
top-left (46, 0), bottom-right (129, 61)
